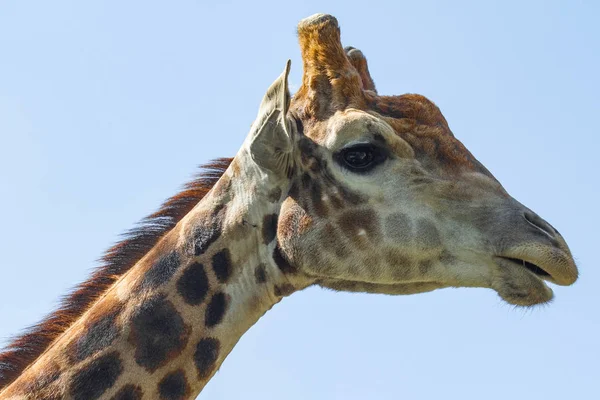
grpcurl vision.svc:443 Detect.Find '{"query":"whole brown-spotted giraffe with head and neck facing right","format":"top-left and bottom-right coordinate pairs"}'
top-left (0, 14), bottom-right (578, 400)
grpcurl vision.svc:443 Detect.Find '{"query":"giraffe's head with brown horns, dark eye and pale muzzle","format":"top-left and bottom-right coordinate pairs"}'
top-left (251, 14), bottom-right (578, 306)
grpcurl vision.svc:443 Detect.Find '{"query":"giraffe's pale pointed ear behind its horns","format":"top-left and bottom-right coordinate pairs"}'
top-left (250, 60), bottom-right (296, 177)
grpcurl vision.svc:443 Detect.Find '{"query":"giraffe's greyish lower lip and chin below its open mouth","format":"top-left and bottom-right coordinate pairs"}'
top-left (492, 258), bottom-right (554, 307)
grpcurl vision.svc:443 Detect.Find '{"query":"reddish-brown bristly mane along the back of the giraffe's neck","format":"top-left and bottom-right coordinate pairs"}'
top-left (0, 158), bottom-right (232, 390)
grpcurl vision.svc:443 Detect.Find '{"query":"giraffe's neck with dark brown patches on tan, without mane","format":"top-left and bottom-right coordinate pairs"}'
top-left (0, 152), bottom-right (308, 400)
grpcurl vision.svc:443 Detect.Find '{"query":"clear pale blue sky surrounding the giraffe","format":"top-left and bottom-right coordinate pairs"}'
top-left (0, 0), bottom-right (600, 400)
